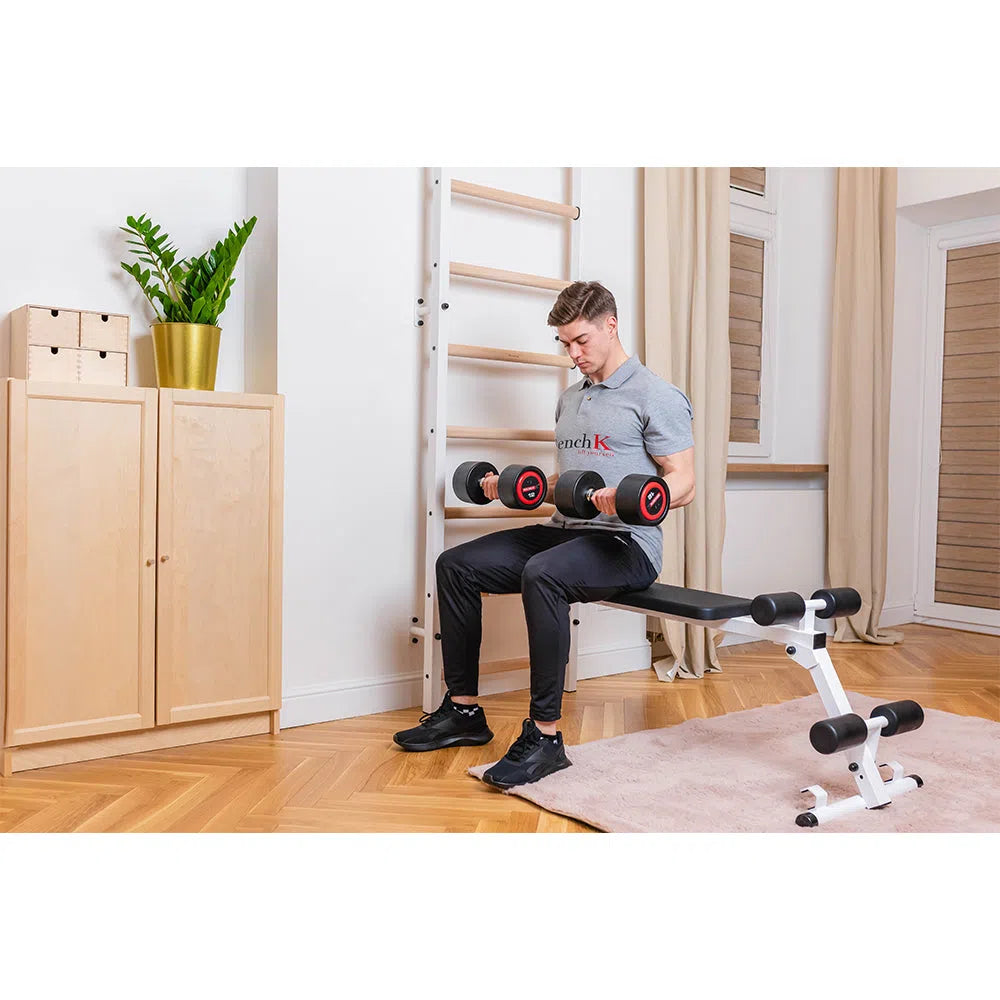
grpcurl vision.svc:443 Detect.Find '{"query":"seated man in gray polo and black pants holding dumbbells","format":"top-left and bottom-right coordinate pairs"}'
top-left (393, 281), bottom-right (695, 788)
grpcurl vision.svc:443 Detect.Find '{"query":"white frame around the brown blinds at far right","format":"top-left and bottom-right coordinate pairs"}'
top-left (913, 215), bottom-right (1000, 630)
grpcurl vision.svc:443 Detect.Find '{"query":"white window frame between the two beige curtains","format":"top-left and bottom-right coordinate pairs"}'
top-left (729, 167), bottom-right (781, 458)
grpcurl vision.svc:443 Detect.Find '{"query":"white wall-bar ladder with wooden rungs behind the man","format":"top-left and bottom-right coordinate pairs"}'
top-left (410, 168), bottom-right (581, 712)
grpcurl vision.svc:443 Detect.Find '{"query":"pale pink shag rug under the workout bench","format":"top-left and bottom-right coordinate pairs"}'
top-left (469, 692), bottom-right (1000, 834)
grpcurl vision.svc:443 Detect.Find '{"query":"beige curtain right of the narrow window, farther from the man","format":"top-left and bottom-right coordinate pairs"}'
top-left (827, 167), bottom-right (903, 644)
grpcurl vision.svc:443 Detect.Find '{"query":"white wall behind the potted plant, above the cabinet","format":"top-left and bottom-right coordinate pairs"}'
top-left (0, 167), bottom-right (248, 392)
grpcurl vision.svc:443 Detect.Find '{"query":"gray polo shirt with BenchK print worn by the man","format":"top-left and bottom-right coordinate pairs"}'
top-left (546, 355), bottom-right (694, 575)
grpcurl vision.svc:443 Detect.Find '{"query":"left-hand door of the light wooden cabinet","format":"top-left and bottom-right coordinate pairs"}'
top-left (6, 379), bottom-right (157, 746)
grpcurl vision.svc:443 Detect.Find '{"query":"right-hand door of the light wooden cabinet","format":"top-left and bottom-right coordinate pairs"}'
top-left (156, 389), bottom-right (284, 725)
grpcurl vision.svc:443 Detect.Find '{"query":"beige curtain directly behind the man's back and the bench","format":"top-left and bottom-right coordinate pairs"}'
top-left (643, 167), bottom-right (730, 680)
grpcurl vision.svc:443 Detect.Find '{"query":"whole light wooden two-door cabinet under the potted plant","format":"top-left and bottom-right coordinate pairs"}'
top-left (0, 379), bottom-right (283, 773)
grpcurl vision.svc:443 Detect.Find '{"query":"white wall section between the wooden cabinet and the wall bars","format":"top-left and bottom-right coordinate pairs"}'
top-left (276, 169), bottom-right (423, 725)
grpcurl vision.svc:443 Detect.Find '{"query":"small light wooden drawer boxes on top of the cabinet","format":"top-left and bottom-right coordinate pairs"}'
top-left (10, 305), bottom-right (129, 385)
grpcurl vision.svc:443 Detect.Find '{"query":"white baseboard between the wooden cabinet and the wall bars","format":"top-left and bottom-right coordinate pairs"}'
top-left (281, 673), bottom-right (423, 729)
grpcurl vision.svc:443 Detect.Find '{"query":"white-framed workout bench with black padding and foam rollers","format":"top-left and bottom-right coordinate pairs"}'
top-left (565, 583), bottom-right (924, 827)
